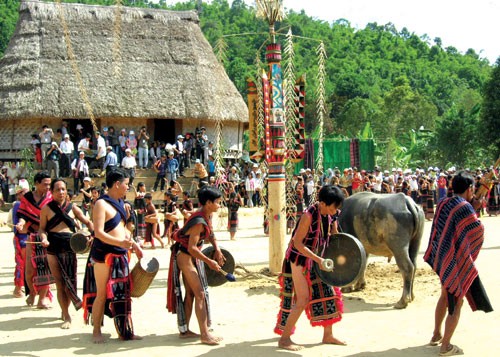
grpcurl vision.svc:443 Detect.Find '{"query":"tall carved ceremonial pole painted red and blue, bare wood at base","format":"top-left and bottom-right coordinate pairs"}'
top-left (256, 0), bottom-right (286, 273)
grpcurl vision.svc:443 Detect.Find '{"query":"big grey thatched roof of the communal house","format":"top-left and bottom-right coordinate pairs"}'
top-left (0, 0), bottom-right (248, 122)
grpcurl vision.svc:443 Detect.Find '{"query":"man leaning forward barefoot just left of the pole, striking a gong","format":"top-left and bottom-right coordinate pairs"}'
top-left (167, 186), bottom-right (225, 345)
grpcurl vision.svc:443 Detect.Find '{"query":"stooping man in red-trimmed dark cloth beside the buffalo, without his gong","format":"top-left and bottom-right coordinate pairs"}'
top-left (274, 185), bottom-right (346, 351)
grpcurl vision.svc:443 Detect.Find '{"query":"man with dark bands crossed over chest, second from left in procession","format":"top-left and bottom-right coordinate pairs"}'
top-left (38, 178), bottom-right (94, 329)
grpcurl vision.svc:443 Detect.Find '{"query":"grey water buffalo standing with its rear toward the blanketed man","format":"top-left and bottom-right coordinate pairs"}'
top-left (339, 192), bottom-right (424, 309)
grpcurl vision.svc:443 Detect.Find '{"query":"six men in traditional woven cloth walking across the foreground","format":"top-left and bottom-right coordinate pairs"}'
top-left (5, 161), bottom-right (491, 356)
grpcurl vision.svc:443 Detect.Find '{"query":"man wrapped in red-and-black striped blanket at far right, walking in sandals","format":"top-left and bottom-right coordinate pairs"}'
top-left (424, 171), bottom-right (493, 356)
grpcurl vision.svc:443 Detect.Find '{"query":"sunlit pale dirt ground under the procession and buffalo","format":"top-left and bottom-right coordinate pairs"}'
top-left (0, 208), bottom-right (500, 357)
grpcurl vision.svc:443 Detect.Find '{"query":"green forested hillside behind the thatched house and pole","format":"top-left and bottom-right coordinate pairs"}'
top-left (0, 0), bottom-right (500, 166)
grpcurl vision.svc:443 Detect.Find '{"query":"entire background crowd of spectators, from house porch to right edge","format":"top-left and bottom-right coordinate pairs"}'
top-left (0, 121), bottom-right (500, 219)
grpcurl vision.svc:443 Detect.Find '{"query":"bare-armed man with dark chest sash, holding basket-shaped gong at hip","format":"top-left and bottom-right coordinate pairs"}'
top-left (83, 169), bottom-right (143, 343)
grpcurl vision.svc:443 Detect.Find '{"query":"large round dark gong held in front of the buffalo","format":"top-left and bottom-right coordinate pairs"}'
top-left (313, 233), bottom-right (366, 287)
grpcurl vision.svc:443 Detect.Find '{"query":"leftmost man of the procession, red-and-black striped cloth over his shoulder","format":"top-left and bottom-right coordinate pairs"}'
top-left (16, 171), bottom-right (53, 309)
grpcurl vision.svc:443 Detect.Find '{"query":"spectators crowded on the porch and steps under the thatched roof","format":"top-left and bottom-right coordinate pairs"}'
top-left (23, 121), bottom-right (215, 191)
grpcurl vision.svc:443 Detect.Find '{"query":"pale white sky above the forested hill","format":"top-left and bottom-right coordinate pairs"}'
top-left (162, 0), bottom-right (500, 64)
